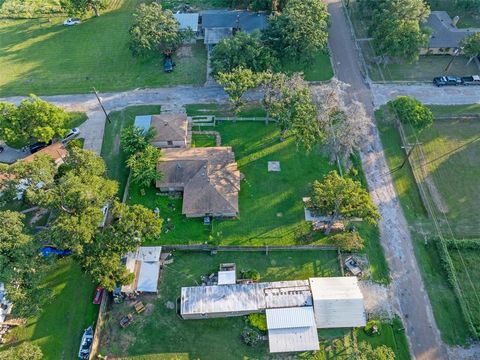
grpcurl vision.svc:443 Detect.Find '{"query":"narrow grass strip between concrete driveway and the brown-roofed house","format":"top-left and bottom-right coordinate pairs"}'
top-left (101, 105), bottom-right (160, 198)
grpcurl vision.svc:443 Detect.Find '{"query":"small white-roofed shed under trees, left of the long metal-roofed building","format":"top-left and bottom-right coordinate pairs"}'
top-left (122, 246), bottom-right (162, 293)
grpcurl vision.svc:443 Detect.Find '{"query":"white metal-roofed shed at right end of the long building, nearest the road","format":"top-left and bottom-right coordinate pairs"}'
top-left (310, 276), bottom-right (366, 328)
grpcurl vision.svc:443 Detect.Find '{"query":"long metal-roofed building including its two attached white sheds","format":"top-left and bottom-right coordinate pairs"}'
top-left (180, 277), bottom-right (366, 353)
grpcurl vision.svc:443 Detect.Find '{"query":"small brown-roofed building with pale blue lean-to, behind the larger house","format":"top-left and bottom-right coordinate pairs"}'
top-left (134, 114), bottom-right (189, 148)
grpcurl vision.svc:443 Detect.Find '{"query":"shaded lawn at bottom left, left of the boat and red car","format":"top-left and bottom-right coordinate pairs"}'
top-left (0, 259), bottom-right (98, 360)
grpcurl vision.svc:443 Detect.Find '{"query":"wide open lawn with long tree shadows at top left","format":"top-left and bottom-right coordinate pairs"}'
top-left (0, 0), bottom-right (206, 96)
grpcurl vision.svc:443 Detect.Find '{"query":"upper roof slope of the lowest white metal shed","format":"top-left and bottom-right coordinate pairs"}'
top-left (266, 306), bottom-right (316, 330)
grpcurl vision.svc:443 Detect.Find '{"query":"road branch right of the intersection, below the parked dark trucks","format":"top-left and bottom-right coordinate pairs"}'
top-left (371, 84), bottom-right (480, 106)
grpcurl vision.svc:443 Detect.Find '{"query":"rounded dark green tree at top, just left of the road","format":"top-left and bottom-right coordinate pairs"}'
top-left (264, 0), bottom-right (329, 62)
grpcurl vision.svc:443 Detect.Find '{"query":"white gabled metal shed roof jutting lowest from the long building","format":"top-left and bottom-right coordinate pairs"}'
top-left (266, 306), bottom-right (320, 353)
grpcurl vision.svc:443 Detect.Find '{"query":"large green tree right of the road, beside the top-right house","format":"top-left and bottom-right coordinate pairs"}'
top-left (364, 0), bottom-right (430, 62)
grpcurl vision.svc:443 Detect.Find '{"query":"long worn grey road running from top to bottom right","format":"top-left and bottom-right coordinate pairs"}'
top-left (325, 0), bottom-right (447, 360)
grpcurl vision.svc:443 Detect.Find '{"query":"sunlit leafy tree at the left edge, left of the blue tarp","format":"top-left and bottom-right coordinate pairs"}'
top-left (0, 210), bottom-right (45, 317)
